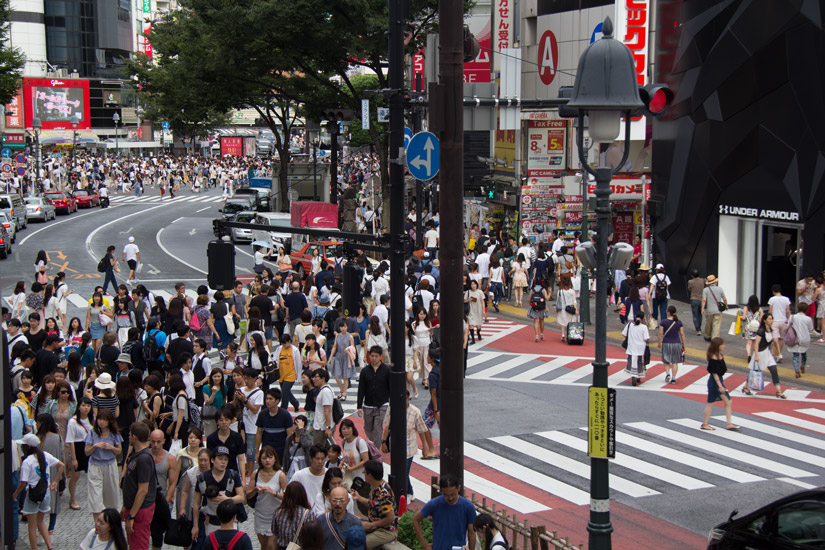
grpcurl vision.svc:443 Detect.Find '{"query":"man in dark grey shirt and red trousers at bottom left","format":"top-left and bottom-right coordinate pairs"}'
top-left (120, 422), bottom-right (157, 548)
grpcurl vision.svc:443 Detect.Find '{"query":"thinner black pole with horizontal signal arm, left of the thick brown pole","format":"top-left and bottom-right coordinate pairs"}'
top-left (388, 0), bottom-right (407, 508)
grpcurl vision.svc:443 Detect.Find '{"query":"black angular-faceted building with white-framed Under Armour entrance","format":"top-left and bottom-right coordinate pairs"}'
top-left (652, 0), bottom-right (825, 304)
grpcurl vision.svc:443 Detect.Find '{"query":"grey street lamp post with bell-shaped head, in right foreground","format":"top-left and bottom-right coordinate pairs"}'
top-left (567, 17), bottom-right (644, 550)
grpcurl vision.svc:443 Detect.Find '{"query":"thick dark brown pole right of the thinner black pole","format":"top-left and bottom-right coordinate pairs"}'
top-left (438, 0), bottom-right (464, 485)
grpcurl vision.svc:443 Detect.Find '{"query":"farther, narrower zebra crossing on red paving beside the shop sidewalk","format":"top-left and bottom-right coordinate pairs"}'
top-left (467, 352), bottom-right (825, 404)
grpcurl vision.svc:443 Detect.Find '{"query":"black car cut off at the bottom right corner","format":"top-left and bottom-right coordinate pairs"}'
top-left (708, 487), bottom-right (825, 550)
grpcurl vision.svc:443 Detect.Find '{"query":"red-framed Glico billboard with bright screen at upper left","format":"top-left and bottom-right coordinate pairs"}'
top-left (23, 78), bottom-right (90, 130)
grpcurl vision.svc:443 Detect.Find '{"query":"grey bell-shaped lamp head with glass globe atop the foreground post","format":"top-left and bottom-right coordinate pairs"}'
top-left (567, 17), bottom-right (644, 143)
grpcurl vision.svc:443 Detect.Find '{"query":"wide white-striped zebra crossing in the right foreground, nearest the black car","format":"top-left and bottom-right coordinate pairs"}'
top-left (387, 409), bottom-right (825, 514)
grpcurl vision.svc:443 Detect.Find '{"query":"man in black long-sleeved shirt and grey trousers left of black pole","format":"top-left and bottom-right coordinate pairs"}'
top-left (357, 346), bottom-right (390, 447)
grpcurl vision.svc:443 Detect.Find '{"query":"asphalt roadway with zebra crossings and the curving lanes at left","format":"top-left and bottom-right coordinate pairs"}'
top-left (6, 190), bottom-right (825, 549)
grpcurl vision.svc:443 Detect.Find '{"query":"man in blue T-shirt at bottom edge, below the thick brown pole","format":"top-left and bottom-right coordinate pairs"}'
top-left (413, 474), bottom-right (476, 550)
